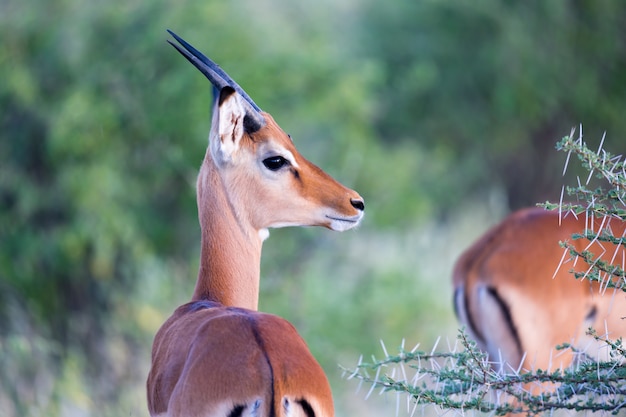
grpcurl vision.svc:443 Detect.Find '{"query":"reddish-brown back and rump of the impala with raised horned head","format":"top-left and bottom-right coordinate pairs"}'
top-left (148, 301), bottom-right (333, 417)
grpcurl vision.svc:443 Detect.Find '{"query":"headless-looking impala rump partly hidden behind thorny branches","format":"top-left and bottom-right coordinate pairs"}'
top-left (453, 208), bottom-right (626, 382)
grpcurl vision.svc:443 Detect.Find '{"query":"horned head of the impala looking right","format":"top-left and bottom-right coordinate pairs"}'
top-left (168, 31), bottom-right (365, 231)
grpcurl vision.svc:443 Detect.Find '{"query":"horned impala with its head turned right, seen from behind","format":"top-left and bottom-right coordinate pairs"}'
top-left (147, 32), bottom-right (364, 417)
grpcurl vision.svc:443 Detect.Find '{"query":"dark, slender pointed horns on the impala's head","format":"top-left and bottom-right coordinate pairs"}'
top-left (167, 29), bottom-right (265, 132)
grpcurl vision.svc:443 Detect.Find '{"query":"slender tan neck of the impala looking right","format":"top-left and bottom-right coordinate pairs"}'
top-left (192, 152), bottom-right (263, 310)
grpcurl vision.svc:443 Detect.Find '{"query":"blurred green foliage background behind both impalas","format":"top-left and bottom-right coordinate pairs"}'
top-left (0, 0), bottom-right (626, 417)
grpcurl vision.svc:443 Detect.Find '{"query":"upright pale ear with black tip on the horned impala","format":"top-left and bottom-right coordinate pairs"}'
top-left (211, 87), bottom-right (246, 165)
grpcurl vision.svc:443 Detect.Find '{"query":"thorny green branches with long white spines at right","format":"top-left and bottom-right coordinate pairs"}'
top-left (349, 128), bottom-right (626, 415)
